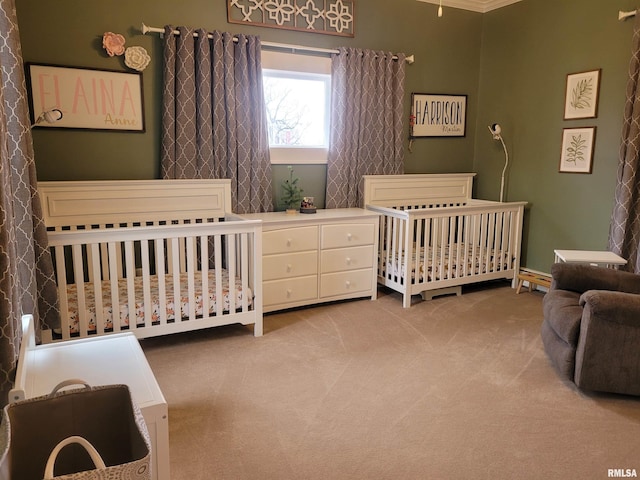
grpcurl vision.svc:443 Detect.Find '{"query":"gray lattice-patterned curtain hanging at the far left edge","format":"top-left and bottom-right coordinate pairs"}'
top-left (0, 0), bottom-right (60, 406)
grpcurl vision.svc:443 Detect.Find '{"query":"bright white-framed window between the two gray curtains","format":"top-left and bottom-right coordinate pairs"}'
top-left (262, 51), bottom-right (331, 164)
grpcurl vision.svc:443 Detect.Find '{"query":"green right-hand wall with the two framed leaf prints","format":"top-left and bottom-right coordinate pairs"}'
top-left (473, 0), bottom-right (636, 272)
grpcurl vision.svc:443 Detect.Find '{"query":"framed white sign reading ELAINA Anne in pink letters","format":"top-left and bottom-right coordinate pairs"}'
top-left (27, 63), bottom-right (145, 132)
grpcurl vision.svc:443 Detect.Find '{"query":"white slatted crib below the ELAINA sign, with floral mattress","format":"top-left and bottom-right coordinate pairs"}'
top-left (38, 180), bottom-right (262, 343)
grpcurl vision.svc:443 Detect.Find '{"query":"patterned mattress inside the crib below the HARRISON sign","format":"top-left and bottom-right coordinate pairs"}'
top-left (383, 244), bottom-right (511, 282)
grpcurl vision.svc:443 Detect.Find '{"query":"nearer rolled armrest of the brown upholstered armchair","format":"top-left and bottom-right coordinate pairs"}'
top-left (580, 290), bottom-right (640, 327)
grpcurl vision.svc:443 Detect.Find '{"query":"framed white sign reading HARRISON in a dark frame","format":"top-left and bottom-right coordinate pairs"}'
top-left (410, 93), bottom-right (467, 138)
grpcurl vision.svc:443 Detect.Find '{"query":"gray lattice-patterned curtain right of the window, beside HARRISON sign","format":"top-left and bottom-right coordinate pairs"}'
top-left (326, 48), bottom-right (405, 208)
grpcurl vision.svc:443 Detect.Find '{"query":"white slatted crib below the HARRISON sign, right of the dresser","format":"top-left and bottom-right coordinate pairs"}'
top-left (364, 173), bottom-right (526, 308)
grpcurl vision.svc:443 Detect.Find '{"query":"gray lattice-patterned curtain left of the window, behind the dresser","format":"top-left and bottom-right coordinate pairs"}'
top-left (162, 26), bottom-right (273, 213)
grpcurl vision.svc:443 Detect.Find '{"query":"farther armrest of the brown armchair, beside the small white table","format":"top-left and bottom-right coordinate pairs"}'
top-left (551, 263), bottom-right (640, 294)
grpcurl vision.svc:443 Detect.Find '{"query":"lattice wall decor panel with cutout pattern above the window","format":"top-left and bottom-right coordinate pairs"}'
top-left (227, 0), bottom-right (355, 37)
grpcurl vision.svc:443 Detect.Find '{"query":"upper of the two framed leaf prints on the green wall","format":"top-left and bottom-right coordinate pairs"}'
top-left (564, 69), bottom-right (601, 120)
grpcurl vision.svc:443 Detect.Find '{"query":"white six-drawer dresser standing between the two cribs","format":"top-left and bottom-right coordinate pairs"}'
top-left (242, 208), bottom-right (379, 312)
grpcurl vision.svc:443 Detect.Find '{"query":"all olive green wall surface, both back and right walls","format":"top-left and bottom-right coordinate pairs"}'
top-left (16, 0), bottom-right (635, 271)
